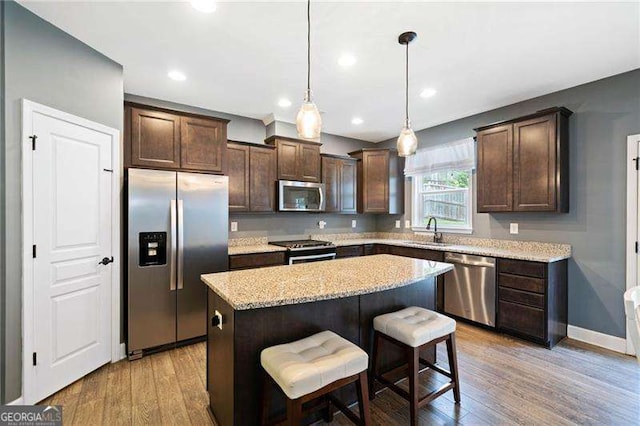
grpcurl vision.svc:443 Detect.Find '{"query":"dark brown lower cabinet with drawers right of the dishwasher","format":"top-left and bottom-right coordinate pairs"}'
top-left (497, 259), bottom-right (567, 348)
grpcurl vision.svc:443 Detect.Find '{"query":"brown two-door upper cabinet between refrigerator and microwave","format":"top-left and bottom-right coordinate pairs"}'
top-left (227, 141), bottom-right (276, 212)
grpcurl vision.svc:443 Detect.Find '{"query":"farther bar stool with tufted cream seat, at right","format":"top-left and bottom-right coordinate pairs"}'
top-left (370, 306), bottom-right (460, 425)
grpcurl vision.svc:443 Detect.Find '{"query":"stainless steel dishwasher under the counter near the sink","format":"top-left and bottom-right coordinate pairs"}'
top-left (444, 253), bottom-right (496, 327)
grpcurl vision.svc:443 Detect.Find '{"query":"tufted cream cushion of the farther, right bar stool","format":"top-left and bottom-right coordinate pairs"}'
top-left (373, 306), bottom-right (456, 348)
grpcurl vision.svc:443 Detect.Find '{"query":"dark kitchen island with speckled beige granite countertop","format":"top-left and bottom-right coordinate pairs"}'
top-left (202, 254), bottom-right (452, 426)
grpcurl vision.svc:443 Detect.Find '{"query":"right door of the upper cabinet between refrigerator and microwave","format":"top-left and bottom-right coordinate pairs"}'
top-left (249, 146), bottom-right (276, 212)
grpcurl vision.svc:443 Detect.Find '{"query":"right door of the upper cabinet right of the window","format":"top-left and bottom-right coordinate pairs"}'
top-left (513, 115), bottom-right (558, 211)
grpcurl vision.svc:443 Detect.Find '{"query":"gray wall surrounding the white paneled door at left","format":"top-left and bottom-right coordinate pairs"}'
top-left (2, 2), bottom-right (124, 402)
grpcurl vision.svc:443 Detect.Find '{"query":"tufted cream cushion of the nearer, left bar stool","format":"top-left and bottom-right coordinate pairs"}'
top-left (260, 331), bottom-right (369, 399)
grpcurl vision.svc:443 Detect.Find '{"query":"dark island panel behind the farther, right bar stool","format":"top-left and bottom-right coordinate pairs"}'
top-left (360, 278), bottom-right (436, 378)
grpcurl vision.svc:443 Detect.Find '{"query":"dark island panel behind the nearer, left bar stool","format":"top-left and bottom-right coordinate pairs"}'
top-left (232, 296), bottom-right (360, 425)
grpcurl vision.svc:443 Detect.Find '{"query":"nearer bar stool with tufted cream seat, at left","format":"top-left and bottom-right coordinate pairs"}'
top-left (260, 331), bottom-right (370, 425)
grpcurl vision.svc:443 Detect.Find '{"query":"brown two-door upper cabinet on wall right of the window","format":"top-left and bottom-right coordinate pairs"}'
top-left (475, 107), bottom-right (572, 213)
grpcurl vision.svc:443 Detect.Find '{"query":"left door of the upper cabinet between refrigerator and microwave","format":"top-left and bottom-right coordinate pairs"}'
top-left (227, 143), bottom-right (250, 212)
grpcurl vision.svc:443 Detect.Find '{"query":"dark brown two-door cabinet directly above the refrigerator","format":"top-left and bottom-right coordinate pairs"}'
top-left (124, 103), bottom-right (228, 174)
